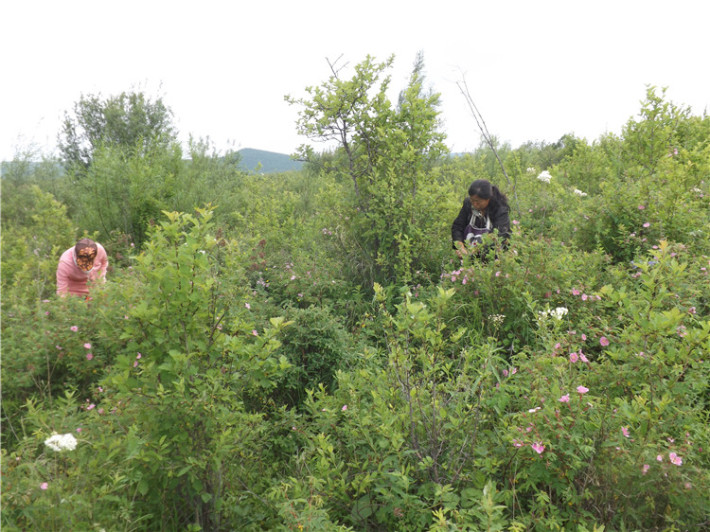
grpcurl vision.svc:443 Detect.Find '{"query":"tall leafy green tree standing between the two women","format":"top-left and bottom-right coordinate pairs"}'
top-left (287, 55), bottom-right (446, 286)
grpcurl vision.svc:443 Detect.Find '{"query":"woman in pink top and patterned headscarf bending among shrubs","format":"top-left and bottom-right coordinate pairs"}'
top-left (57, 238), bottom-right (108, 296)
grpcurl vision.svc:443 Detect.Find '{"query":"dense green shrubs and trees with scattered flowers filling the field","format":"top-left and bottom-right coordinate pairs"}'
top-left (2, 57), bottom-right (710, 531)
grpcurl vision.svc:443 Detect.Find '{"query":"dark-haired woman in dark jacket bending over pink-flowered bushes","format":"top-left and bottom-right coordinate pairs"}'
top-left (451, 179), bottom-right (510, 257)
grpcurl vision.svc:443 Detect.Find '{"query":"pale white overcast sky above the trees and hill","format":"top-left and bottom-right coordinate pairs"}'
top-left (0, 0), bottom-right (710, 160)
